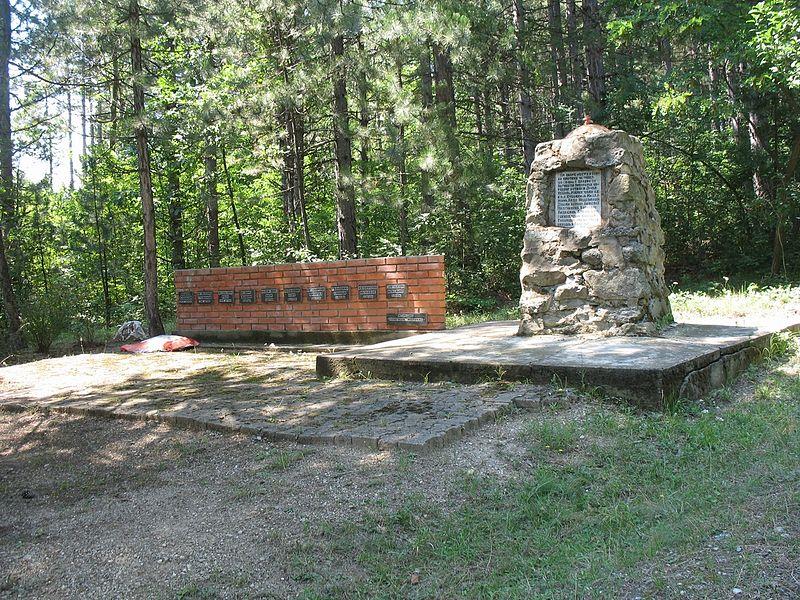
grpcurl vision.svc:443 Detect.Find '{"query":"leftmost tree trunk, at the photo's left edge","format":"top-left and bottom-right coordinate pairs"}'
top-left (0, 0), bottom-right (25, 350)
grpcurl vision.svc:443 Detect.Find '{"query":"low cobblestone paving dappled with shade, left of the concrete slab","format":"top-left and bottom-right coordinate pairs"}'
top-left (0, 352), bottom-right (547, 451)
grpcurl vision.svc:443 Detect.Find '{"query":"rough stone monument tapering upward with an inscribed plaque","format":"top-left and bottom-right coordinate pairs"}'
top-left (519, 118), bottom-right (671, 335)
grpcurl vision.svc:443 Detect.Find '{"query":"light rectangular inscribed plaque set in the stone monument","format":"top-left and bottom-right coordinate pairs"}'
top-left (555, 171), bottom-right (600, 229)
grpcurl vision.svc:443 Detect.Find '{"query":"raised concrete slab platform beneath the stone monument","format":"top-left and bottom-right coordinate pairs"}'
top-left (316, 320), bottom-right (800, 408)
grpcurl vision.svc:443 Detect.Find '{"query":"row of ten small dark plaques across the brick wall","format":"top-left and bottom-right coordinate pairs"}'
top-left (178, 283), bottom-right (408, 304)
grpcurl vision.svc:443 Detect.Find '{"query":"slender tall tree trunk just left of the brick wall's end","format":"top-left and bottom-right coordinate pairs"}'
top-left (129, 0), bottom-right (164, 336)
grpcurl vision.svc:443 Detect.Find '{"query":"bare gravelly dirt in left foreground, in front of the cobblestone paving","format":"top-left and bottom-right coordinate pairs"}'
top-left (0, 392), bottom-right (536, 598)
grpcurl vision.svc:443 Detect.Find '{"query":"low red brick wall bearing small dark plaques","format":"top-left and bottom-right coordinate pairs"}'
top-left (175, 256), bottom-right (445, 332)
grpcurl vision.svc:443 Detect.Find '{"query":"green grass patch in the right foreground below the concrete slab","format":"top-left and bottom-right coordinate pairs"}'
top-left (294, 356), bottom-right (800, 599)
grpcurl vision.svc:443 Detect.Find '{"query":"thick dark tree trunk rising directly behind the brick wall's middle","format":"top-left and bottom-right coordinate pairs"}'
top-left (331, 34), bottom-right (358, 258)
